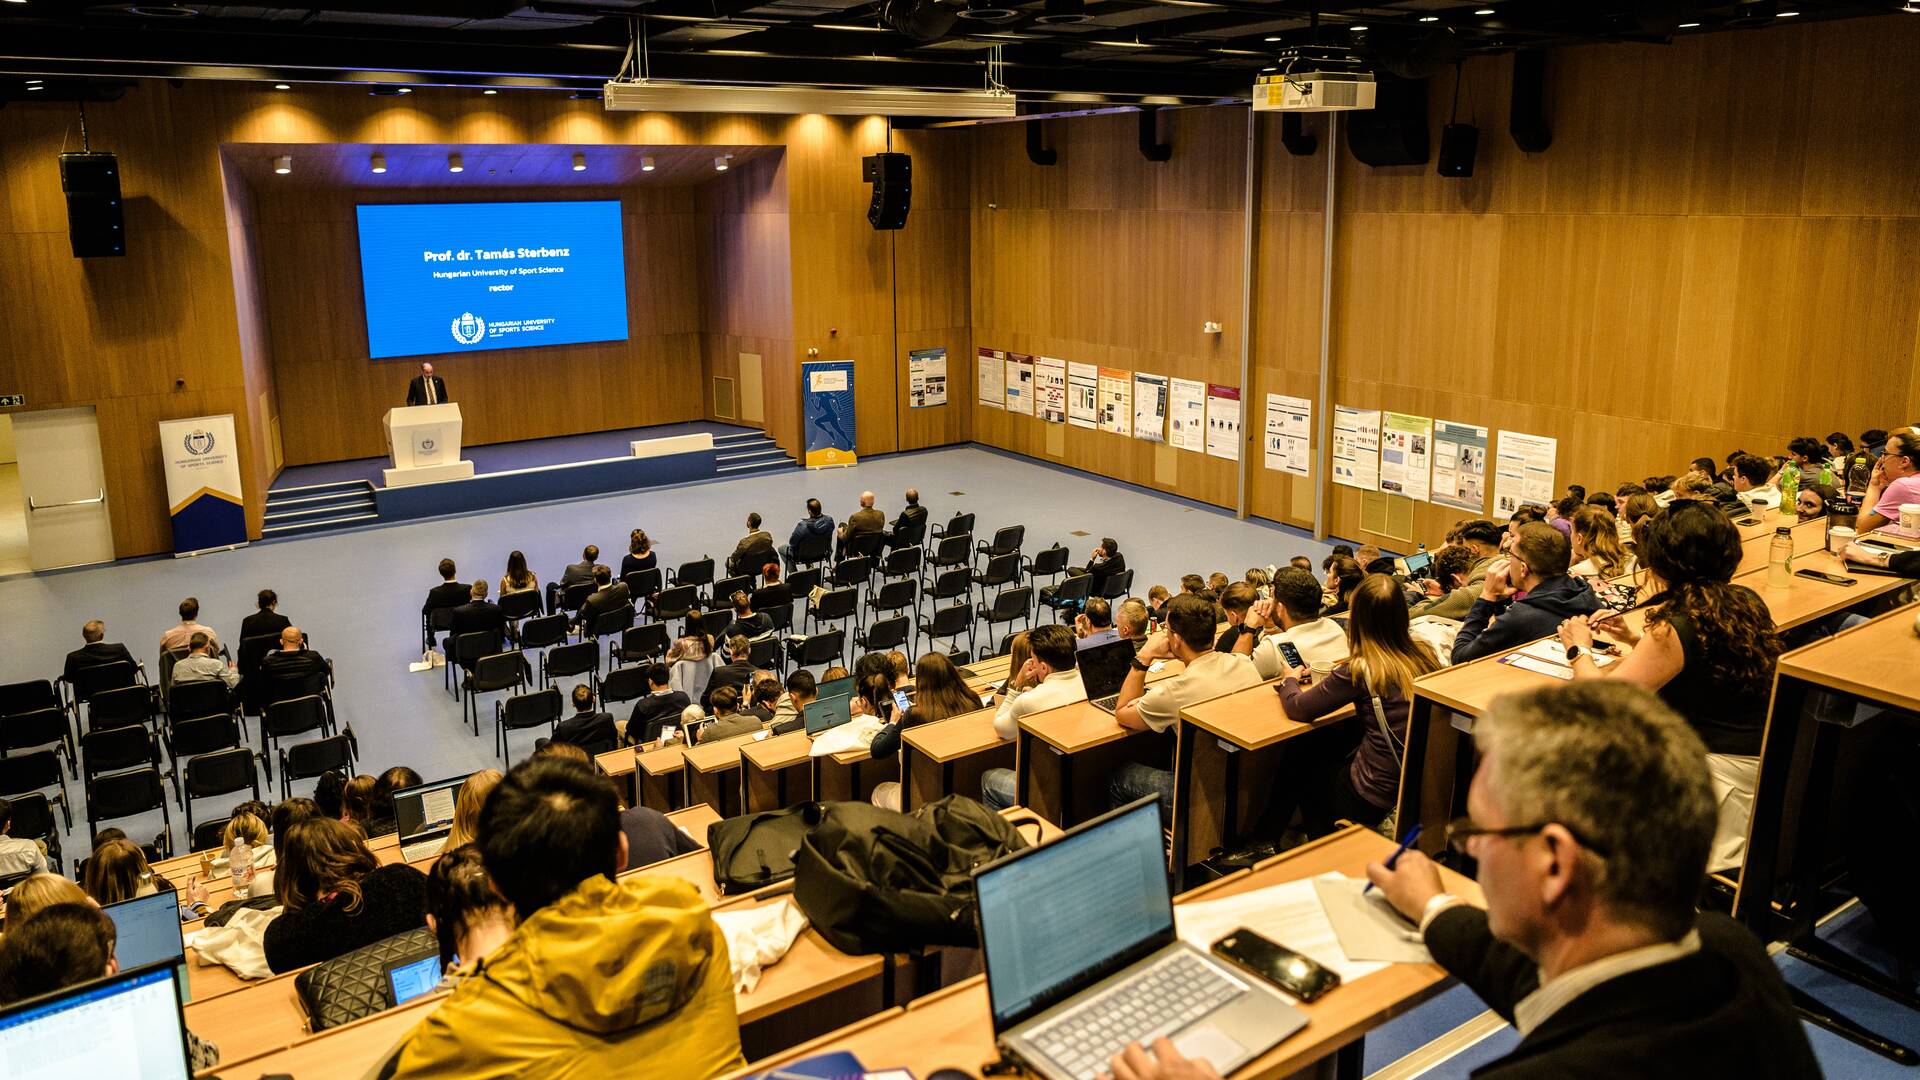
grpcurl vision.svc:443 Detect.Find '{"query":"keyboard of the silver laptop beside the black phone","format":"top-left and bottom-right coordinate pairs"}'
top-left (1027, 949), bottom-right (1246, 1080)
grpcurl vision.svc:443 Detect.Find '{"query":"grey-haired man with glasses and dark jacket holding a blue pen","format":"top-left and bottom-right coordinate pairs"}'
top-left (1114, 678), bottom-right (1820, 1080)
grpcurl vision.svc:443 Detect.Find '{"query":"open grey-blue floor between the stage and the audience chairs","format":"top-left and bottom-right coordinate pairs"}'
top-left (0, 448), bottom-right (1329, 863)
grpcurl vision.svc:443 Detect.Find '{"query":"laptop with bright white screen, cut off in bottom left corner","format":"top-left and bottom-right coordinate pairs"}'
top-left (0, 953), bottom-right (192, 1080)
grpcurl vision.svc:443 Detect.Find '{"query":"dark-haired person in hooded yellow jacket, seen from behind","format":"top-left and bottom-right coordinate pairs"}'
top-left (397, 757), bottom-right (743, 1080)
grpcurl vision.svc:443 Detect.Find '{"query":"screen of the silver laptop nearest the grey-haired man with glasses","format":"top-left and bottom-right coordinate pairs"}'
top-left (973, 799), bottom-right (1173, 1032)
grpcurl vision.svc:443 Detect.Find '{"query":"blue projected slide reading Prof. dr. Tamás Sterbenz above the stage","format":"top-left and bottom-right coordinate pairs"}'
top-left (355, 200), bottom-right (626, 359)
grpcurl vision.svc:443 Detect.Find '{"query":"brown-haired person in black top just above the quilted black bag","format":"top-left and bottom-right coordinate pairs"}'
top-left (263, 817), bottom-right (426, 972)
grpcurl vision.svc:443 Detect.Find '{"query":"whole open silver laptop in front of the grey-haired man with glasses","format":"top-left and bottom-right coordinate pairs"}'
top-left (973, 798), bottom-right (1308, 1080)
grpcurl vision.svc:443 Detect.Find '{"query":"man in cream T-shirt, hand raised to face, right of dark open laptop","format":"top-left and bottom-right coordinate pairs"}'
top-left (1113, 596), bottom-right (1260, 824)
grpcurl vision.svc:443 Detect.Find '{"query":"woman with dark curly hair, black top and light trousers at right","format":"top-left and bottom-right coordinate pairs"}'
top-left (1559, 503), bottom-right (1784, 871)
